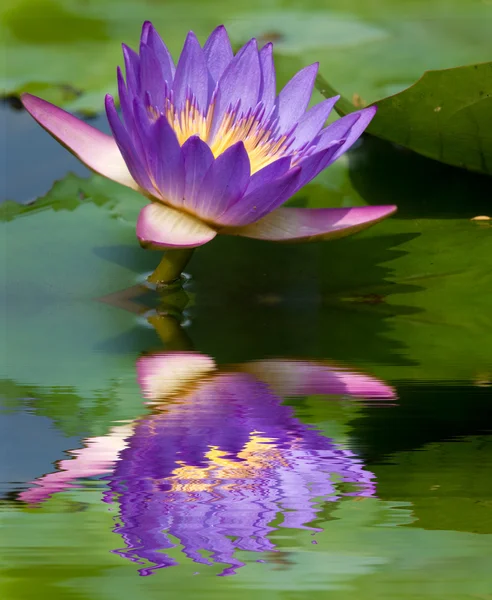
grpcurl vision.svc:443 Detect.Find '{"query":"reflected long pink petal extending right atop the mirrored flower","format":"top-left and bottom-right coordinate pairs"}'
top-left (240, 359), bottom-right (395, 399)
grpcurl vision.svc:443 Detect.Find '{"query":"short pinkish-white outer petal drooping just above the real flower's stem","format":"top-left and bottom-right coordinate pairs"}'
top-left (137, 202), bottom-right (217, 250)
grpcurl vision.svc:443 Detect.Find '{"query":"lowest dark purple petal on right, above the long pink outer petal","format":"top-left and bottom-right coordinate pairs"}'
top-left (217, 167), bottom-right (301, 227)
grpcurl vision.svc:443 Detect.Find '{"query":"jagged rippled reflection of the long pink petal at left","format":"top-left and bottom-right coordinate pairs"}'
top-left (20, 425), bottom-right (133, 504)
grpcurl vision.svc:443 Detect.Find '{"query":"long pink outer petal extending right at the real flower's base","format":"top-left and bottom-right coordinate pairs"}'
top-left (225, 206), bottom-right (396, 242)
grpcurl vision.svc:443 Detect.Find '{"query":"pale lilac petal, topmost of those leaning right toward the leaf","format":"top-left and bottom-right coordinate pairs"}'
top-left (276, 63), bottom-right (319, 132)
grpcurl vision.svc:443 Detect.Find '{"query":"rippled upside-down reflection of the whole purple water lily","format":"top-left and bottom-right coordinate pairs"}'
top-left (21, 352), bottom-right (393, 575)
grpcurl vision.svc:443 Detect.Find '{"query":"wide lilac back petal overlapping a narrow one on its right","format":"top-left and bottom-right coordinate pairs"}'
top-left (211, 39), bottom-right (261, 139)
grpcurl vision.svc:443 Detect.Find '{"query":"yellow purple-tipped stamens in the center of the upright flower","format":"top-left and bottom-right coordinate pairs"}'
top-left (164, 99), bottom-right (293, 174)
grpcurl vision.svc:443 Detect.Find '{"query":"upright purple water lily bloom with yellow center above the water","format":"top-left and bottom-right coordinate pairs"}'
top-left (22, 22), bottom-right (396, 249)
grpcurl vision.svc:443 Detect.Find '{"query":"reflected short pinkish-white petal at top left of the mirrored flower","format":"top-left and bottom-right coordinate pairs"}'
top-left (137, 352), bottom-right (216, 401)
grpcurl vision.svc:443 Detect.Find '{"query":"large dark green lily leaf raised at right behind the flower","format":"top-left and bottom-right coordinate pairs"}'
top-left (317, 62), bottom-right (492, 174)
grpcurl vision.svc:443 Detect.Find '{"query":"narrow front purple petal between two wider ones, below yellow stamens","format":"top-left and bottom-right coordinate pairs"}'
top-left (181, 135), bottom-right (214, 212)
